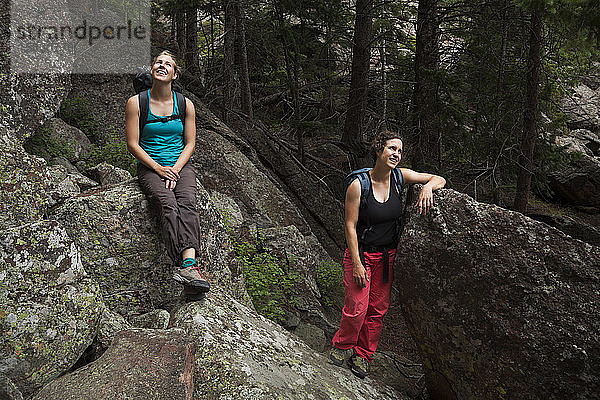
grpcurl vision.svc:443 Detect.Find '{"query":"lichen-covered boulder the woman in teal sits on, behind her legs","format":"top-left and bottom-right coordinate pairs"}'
top-left (53, 182), bottom-right (247, 316)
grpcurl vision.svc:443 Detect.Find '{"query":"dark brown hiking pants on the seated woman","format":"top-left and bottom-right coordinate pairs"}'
top-left (137, 162), bottom-right (200, 266)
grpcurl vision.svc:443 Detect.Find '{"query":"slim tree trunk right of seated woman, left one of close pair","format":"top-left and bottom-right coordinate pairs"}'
top-left (222, 0), bottom-right (235, 123)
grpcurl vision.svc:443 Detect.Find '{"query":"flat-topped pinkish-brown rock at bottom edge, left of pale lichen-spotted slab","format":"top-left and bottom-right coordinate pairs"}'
top-left (34, 329), bottom-right (196, 400)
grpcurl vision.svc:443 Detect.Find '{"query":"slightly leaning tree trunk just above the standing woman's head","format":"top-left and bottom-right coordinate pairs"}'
top-left (342, 0), bottom-right (373, 161)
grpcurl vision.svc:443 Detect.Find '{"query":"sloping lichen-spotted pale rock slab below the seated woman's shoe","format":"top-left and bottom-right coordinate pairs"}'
top-left (173, 291), bottom-right (404, 400)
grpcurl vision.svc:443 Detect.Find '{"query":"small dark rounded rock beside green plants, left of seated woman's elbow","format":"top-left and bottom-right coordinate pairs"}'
top-left (23, 118), bottom-right (92, 164)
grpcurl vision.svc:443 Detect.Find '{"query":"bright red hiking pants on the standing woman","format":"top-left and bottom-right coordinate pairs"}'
top-left (333, 249), bottom-right (396, 362)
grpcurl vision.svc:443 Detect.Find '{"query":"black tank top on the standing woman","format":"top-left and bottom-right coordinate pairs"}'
top-left (356, 174), bottom-right (402, 248)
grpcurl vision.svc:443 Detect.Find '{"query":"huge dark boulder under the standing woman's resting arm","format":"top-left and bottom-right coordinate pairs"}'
top-left (395, 187), bottom-right (600, 399)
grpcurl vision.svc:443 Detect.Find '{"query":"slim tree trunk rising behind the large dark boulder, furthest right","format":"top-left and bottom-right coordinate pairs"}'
top-left (514, 9), bottom-right (542, 212)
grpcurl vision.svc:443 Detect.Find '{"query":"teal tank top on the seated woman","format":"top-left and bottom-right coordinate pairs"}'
top-left (140, 89), bottom-right (184, 167)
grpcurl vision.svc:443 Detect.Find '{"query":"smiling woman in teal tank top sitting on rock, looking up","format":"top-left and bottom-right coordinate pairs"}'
top-left (125, 51), bottom-right (210, 293)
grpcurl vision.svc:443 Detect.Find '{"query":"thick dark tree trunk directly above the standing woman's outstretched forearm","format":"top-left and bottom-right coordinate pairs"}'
top-left (410, 0), bottom-right (442, 169)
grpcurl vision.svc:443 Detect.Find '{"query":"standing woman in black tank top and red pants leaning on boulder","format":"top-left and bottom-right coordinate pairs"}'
top-left (329, 130), bottom-right (446, 378)
